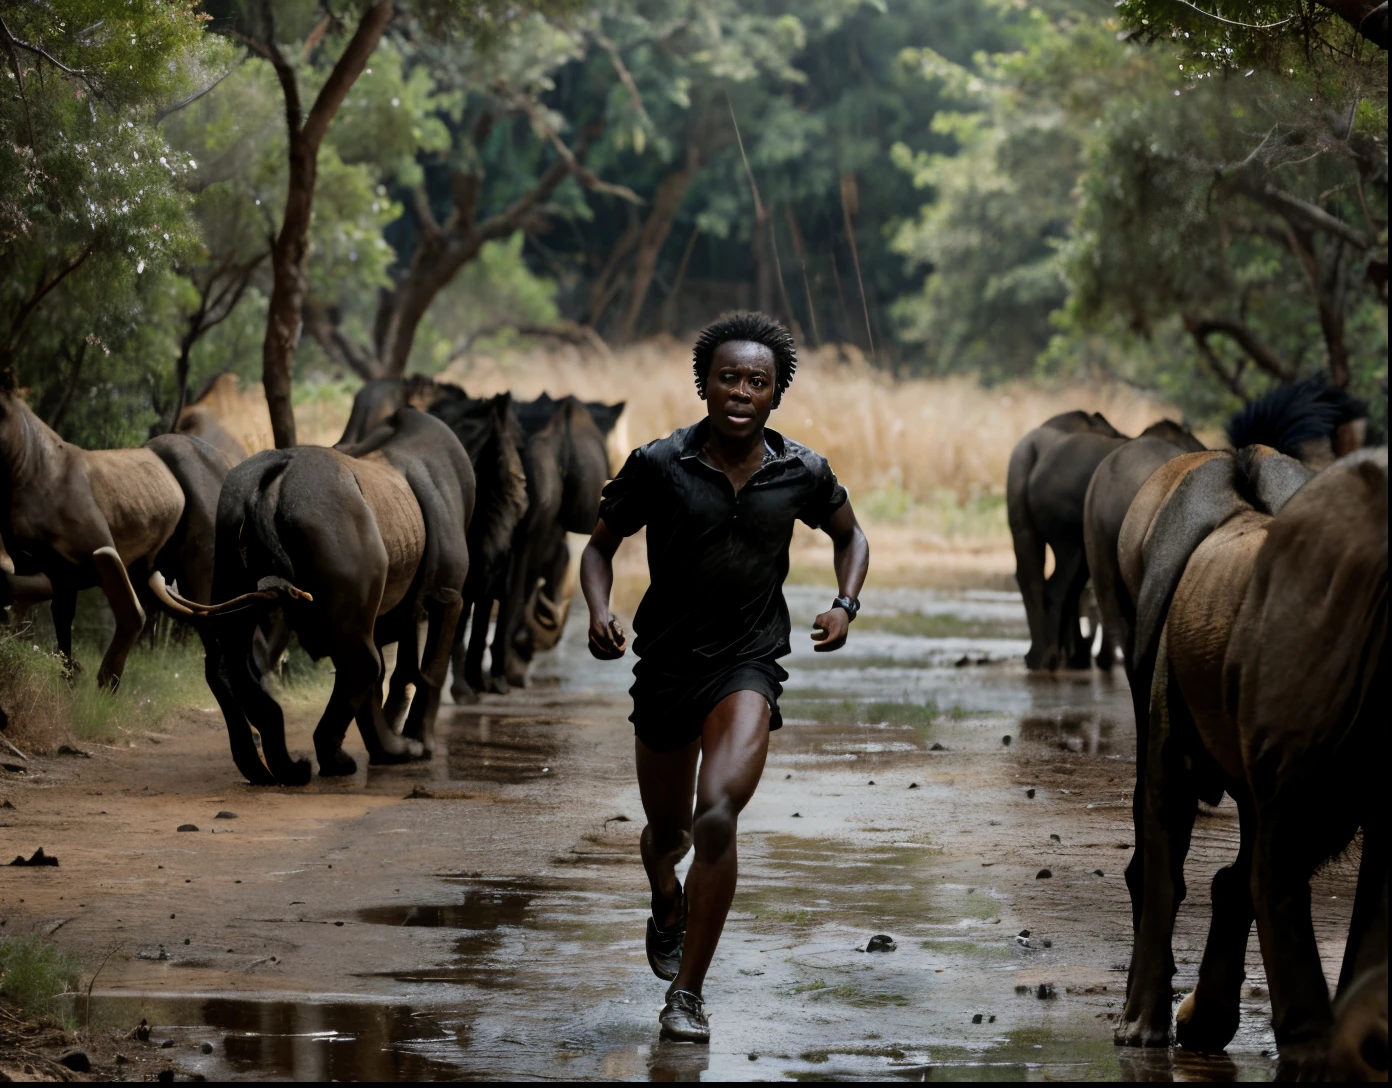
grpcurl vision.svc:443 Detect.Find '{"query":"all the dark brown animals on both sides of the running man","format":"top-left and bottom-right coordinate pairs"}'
top-left (0, 376), bottom-right (1388, 1080)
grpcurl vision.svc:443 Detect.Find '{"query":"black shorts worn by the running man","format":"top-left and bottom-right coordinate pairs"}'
top-left (628, 658), bottom-right (788, 751)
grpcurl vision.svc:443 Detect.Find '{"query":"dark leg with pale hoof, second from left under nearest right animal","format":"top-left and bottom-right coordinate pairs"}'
top-left (1175, 792), bottom-right (1254, 1053)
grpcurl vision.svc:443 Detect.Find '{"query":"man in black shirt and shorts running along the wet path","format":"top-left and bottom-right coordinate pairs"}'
top-left (580, 313), bottom-right (870, 1042)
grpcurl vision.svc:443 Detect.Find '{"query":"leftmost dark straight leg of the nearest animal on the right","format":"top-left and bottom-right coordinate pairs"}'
top-left (1115, 630), bottom-right (1199, 1046)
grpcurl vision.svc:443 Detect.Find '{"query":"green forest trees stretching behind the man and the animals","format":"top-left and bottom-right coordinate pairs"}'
top-left (0, 0), bottom-right (1388, 459)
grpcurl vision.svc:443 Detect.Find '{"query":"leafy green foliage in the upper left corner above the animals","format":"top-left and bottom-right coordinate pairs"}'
top-left (0, 0), bottom-right (202, 444)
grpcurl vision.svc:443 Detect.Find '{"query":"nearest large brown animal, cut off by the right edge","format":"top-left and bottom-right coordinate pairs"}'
top-left (1116, 447), bottom-right (1386, 1077)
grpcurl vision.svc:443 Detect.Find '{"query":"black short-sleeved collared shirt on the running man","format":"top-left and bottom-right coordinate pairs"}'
top-left (600, 420), bottom-right (846, 675)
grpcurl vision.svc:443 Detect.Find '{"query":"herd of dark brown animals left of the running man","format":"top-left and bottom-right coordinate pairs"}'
top-left (0, 378), bottom-right (624, 785)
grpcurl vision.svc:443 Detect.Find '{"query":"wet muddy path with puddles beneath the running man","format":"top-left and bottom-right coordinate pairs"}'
top-left (0, 587), bottom-right (1356, 1080)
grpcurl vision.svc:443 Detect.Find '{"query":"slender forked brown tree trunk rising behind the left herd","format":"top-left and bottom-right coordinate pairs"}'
top-left (259, 0), bottom-right (393, 449)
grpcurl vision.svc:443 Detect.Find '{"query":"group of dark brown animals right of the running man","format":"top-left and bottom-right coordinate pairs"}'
top-left (1008, 380), bottom-right (1388, 1080)
